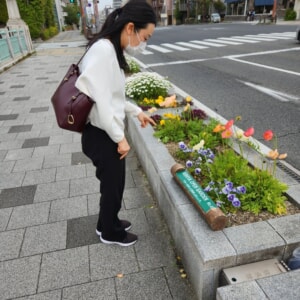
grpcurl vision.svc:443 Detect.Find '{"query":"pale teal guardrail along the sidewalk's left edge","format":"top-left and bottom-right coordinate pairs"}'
top-left (0, 28), bottom-right (32, 72)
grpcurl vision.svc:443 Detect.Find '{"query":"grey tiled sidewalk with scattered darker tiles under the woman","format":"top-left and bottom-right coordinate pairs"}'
top-left (0, 32), bottom-right (195, 300)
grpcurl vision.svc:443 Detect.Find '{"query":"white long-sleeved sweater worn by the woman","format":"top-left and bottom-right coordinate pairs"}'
top-left (76, 39), bottom-right (142, 143)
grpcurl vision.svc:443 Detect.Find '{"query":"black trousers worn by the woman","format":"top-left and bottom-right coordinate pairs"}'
top-left (81, 123), bottom-right (126, 240)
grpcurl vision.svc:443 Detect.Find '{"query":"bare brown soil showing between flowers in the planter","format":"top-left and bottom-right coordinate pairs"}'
top-left (166, 143), bottom-right (300, 227)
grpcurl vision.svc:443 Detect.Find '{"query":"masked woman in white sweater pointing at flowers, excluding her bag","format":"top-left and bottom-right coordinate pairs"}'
top-left (76, 0), bottom-right (156, 246)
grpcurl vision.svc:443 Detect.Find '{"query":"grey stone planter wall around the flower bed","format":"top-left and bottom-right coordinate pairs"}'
top-left (128, 93), bottom-right (300, 300)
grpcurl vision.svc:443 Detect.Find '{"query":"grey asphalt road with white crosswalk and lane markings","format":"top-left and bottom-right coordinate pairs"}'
top-left (137, 22), bottom-right (300, 170)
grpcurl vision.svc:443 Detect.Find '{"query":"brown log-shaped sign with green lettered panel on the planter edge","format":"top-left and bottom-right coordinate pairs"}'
top-left (171, 164), bottom-right (227, 231)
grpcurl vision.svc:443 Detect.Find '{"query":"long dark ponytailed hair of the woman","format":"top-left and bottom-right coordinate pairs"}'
top-left (88, 0), bottom-right (156, 70)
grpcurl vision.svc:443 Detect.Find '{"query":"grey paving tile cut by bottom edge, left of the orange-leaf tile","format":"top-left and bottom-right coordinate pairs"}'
top-left (62, 278), bottom-right (117, 300)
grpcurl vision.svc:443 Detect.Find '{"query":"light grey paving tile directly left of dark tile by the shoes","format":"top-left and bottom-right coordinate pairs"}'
top-left (20, 221), bottom-right (67, 257)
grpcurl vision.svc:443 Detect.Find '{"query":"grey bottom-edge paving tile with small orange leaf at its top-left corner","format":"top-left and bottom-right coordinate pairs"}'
top-left (116, 269), bottom-right (173, 300)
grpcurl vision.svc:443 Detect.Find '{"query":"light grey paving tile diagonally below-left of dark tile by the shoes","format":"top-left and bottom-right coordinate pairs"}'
top-left (38, 247), bottom-right (90, 292)
